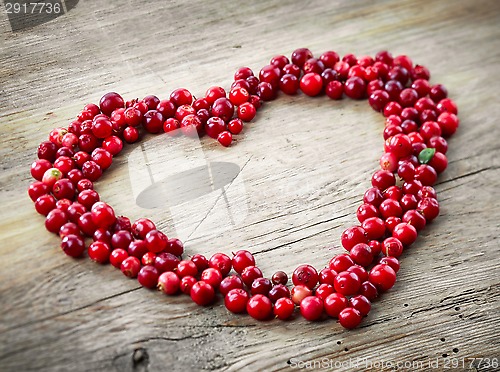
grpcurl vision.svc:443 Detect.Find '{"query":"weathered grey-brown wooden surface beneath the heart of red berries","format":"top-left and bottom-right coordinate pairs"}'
top-left (0, 0), bottom-right (500, 371)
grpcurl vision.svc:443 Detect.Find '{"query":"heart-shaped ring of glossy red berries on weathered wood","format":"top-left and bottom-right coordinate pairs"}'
top-left (28, 48), bottom-right (459, 328)
